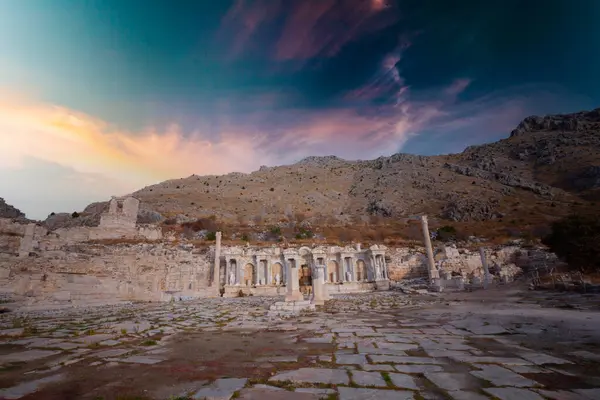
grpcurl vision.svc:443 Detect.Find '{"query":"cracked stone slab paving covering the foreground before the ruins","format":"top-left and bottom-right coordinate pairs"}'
top-left (0, 292), bottom-right (600, 400)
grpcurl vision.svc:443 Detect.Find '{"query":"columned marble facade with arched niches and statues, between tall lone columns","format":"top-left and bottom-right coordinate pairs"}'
top-left (219, 244), bottom-right (389, 297)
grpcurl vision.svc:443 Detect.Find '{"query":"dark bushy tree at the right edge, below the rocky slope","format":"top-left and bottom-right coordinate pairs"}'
top-left (542, 215), bottom-right (600, 272)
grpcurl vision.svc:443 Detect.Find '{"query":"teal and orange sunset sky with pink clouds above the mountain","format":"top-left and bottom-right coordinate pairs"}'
top-left (0, 0), bottom-right (600, 219)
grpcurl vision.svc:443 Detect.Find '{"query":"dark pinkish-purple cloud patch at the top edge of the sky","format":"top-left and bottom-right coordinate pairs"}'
top-left (220, 0), bottom-right (398, 61)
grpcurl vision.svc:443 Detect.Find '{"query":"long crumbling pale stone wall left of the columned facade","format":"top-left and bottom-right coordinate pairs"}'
top-left (0, 239), bottom-right (217, 304)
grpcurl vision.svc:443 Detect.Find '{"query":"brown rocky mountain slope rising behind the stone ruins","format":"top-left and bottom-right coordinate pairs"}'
top-left (125, 109), bottom-right (600, 233)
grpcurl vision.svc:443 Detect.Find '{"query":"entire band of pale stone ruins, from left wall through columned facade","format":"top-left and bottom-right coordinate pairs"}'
top-left (0, 197), bottom-right (549, 307)
